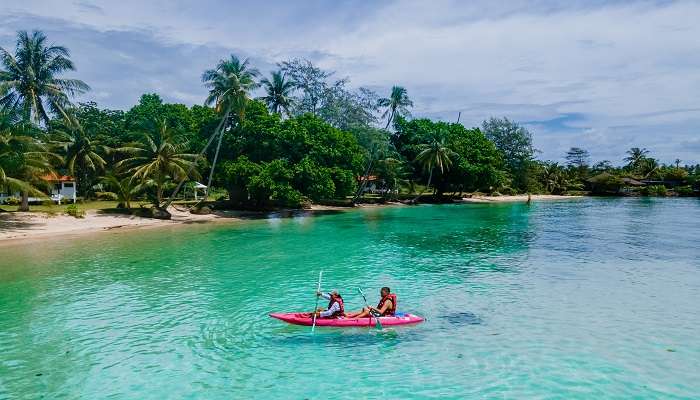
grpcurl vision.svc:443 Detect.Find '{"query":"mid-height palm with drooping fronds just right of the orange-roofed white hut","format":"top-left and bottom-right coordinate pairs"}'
top-left (55, 127), bottom-right (110, 194)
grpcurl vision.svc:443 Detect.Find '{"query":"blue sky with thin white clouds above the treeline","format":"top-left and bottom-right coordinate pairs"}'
top-left (0, 0), bottom-right (700, 164)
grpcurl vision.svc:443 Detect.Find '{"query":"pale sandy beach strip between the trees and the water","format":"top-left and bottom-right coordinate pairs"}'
top-left (0, 195), bottom-right (582, 247)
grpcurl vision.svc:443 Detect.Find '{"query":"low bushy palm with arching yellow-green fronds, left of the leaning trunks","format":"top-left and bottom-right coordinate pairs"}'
top-left (115, 120), bottom-right (199, 207)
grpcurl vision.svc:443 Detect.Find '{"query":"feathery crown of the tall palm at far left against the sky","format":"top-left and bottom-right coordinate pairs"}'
top-left (0, 31), bottom-right (90, 124)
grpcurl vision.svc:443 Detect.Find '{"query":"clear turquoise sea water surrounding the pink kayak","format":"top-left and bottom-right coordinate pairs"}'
top-left (0, 199), bottom-right (700, 399)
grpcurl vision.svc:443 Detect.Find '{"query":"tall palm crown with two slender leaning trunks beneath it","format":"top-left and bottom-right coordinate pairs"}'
top-left (163, 54), bottom-right (260, 208)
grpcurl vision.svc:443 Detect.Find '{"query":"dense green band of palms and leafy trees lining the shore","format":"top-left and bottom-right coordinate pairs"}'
top-left (0, 31), bottom-right (700, 219)
